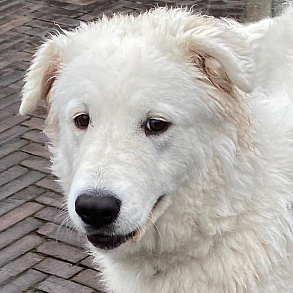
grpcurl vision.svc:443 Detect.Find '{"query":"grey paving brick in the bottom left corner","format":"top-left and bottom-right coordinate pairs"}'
top-left (0, 269), bottom-right (47, 293)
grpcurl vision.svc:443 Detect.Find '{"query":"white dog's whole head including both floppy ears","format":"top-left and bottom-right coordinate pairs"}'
top-left (20, 9), bottom-right (253, 249)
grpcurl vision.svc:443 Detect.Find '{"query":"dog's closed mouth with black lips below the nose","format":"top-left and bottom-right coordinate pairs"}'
top-left (87, 195), bottom-right (164, 250)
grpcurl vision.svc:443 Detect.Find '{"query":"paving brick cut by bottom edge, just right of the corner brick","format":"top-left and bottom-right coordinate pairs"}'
top-left (36, 276), bottom-right (95, 293)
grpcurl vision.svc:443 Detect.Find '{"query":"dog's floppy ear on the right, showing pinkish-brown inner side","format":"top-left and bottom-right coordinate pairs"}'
top-left (184, 16), bottom-right (255, 93)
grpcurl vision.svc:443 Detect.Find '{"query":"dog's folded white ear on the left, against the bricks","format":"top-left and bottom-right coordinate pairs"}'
top-left (19, 35), bottom-right (68, 114)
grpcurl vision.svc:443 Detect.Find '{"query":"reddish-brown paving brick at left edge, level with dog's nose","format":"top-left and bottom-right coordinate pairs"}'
top-left (0, 202), bottom-right (43, 231)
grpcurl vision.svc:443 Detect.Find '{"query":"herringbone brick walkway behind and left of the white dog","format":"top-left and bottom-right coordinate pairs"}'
top-left (0, 0), bottom-right (272, 293)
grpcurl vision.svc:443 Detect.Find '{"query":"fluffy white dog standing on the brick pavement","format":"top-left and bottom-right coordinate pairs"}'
top-left (20, 9), bottom-right (293, 293)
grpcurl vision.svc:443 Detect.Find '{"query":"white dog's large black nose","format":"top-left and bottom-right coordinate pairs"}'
top-left (75, 193), bottom-right (121, 229)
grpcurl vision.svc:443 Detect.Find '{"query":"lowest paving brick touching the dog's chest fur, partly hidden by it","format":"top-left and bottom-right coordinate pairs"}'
top-left (72, 269), bottom-right (106, 292)
